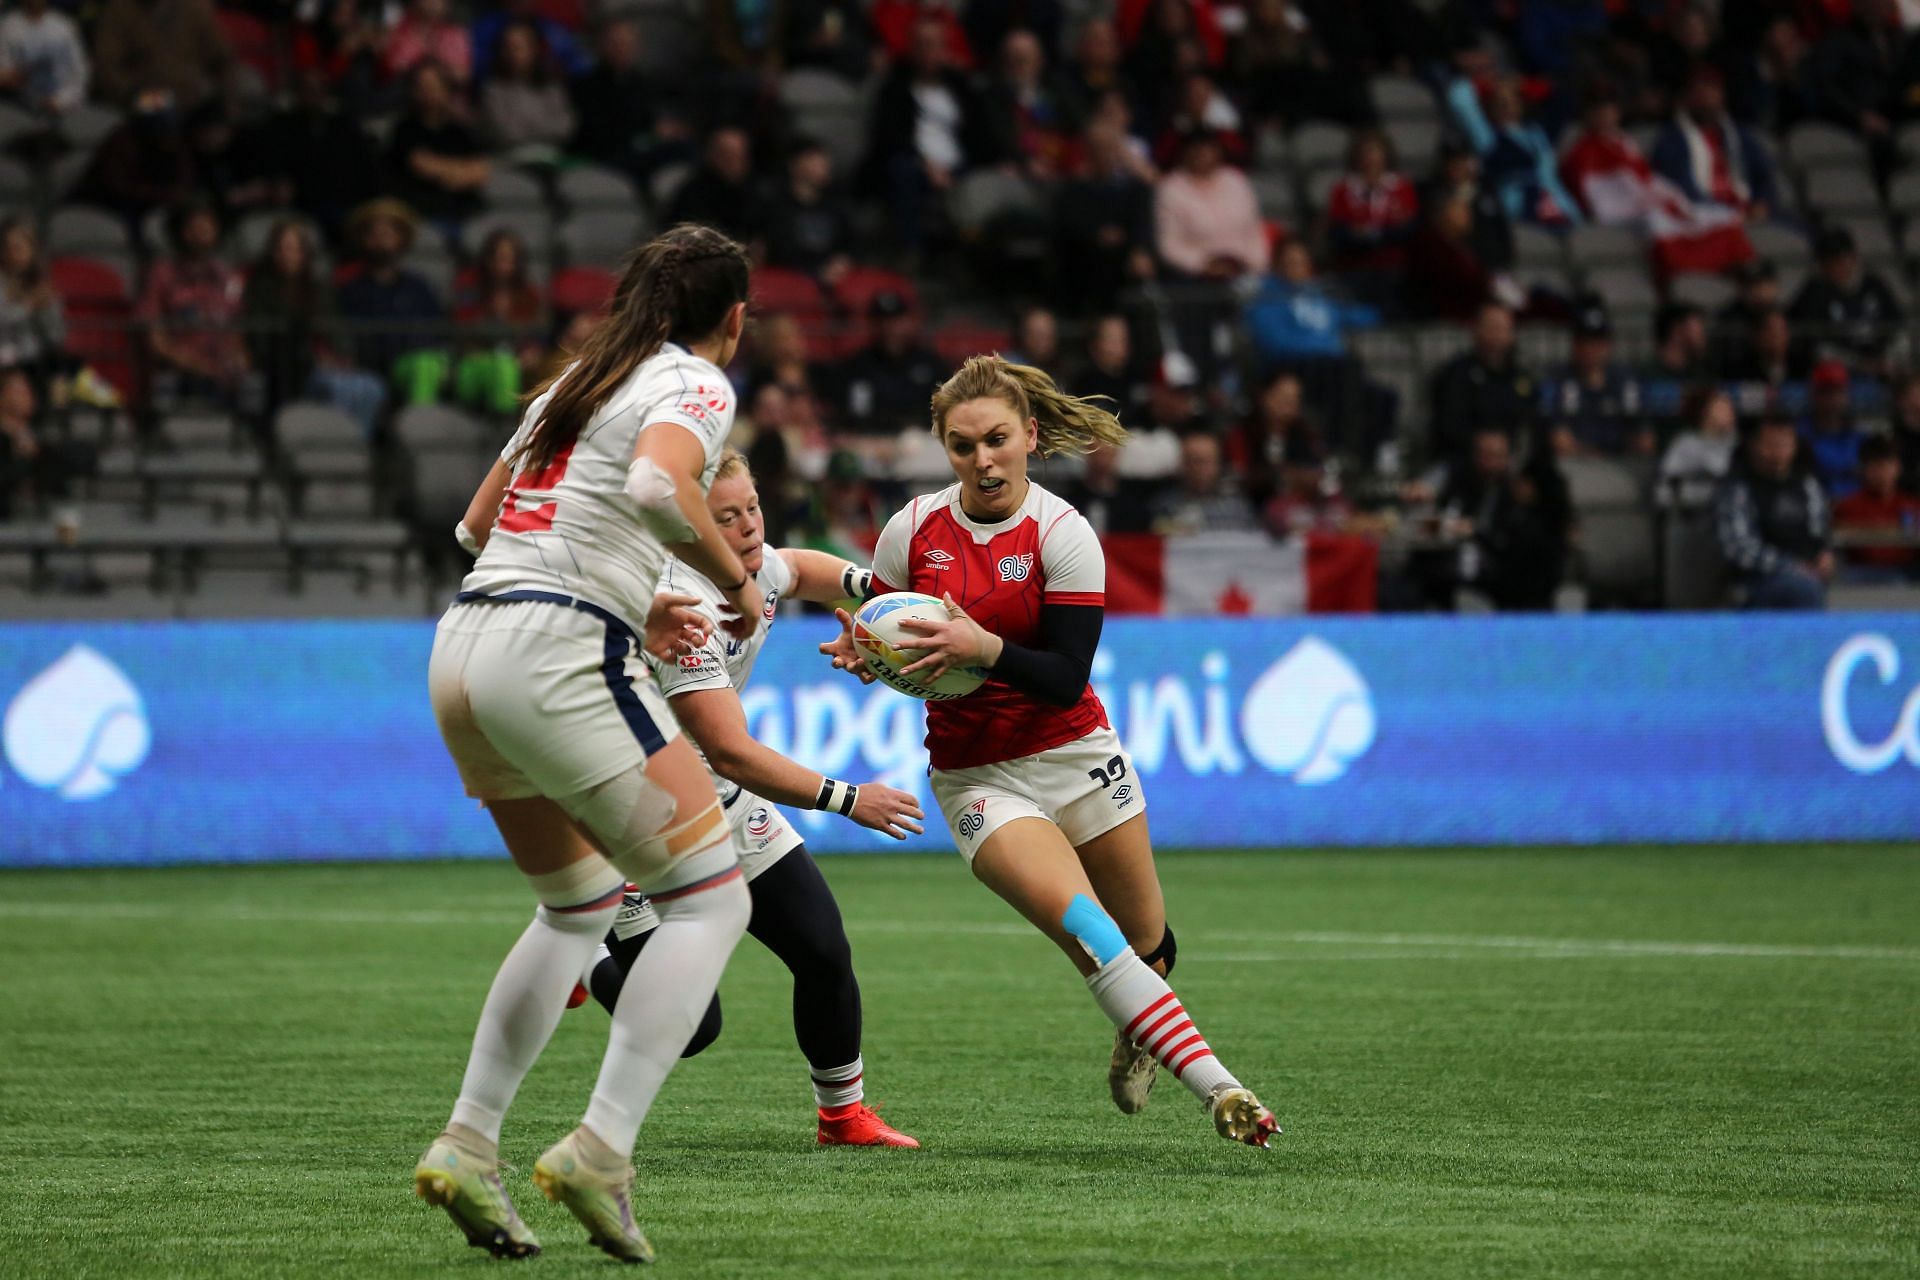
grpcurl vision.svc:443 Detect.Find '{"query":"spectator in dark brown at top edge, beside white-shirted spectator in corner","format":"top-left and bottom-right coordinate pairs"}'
top-left (94, 0), bottom-right (234, 107)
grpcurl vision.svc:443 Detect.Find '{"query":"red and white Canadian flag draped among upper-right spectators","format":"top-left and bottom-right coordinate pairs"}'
top-left (1561, 132), bottom-right (1753, 280)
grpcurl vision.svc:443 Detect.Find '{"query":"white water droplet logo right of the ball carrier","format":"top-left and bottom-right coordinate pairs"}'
top-left (1240, 635), bottom-right (1375, 787)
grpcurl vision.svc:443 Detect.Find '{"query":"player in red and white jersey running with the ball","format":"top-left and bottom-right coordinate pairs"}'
top-left (820, 355), bottom-right (1279, 1146)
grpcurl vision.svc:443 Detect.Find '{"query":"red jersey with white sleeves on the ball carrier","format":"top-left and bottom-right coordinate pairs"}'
top-left (874, 484), bottom-right (1106, 770)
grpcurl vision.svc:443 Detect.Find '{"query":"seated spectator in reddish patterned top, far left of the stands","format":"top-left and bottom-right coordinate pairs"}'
top-left (134, 200), bottom-right (257, 409)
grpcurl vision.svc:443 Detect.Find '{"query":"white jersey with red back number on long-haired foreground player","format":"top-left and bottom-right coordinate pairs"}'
top-left (461, 344), bottom-right (733, 631)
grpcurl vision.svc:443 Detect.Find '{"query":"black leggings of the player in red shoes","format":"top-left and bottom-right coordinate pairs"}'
top-left (591, 844), bottom-right (860, 1071)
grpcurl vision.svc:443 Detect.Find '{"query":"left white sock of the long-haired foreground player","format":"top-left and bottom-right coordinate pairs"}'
top-left (447, 896), bottom-right (620, 1142)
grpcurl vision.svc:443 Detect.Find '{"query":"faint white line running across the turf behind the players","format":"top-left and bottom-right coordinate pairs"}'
top-left (0, 902), bottom-right (1920, 961)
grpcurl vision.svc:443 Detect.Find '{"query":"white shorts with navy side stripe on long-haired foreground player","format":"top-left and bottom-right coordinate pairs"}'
top-left (426, 593), bottom-right (680, 800)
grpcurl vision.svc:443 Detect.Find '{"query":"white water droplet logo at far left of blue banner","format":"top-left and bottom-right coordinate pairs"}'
top-left (0, 645), bottom-right (152, 800)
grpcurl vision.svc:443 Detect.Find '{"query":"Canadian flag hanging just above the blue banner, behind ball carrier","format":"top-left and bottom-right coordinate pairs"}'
top-left (1104, 533), bottom-right (1380, 614)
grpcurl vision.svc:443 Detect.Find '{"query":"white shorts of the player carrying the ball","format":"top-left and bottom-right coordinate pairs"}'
top-left (933, 729), bottom-right (1146, 862)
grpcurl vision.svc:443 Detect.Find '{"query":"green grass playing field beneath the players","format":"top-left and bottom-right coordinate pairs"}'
top-left (0, 848), bottom-right (1920, 1280)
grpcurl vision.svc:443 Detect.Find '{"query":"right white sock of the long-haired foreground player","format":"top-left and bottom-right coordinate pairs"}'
top-left (584, 867), bottom-right (753, 1159)
